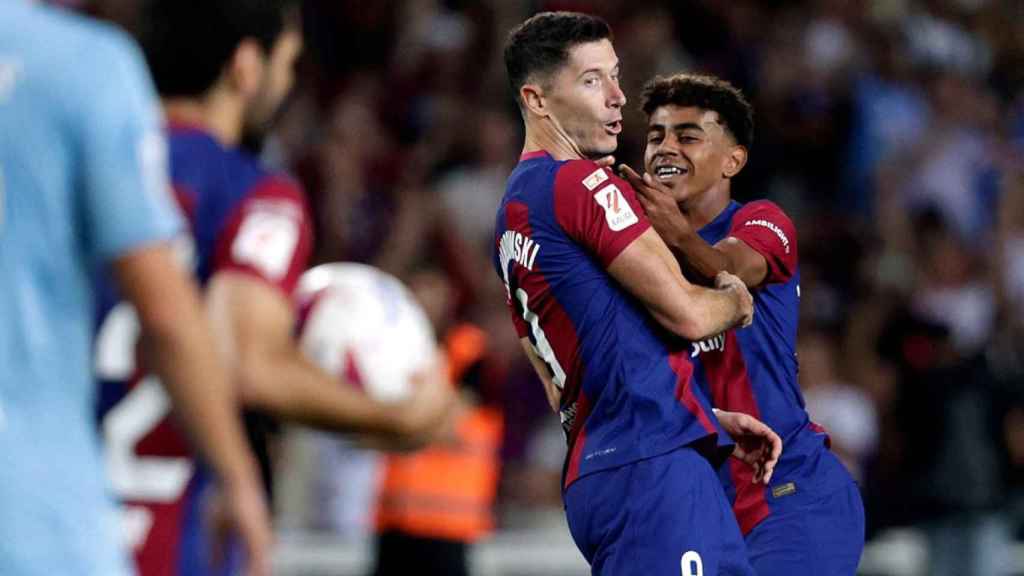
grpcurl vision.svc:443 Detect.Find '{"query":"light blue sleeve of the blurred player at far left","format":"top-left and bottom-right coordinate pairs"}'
top-left (74, 32), bottom-right (183, 260)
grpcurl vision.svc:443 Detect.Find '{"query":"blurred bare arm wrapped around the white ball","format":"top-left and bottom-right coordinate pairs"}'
top-left (207, 271), bottom-right (453, 444)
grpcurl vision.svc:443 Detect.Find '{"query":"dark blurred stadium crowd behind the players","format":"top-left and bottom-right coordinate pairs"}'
top-left (72, 0), bottom-right (1024, 576)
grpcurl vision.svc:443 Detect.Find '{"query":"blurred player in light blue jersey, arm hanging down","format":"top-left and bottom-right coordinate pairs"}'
top-left (0, 1), bottom-right (270, 576)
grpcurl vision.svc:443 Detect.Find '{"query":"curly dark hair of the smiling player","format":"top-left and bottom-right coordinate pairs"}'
top-left (640, 74), bottom-right (754, 148)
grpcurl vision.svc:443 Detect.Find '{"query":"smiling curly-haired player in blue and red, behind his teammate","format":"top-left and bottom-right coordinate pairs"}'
top-left (623, 74), bottom-right (864, 576)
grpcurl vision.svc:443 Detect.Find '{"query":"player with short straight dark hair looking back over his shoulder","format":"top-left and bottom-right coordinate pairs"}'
top-left (494, 12), bottom-right (779, 576)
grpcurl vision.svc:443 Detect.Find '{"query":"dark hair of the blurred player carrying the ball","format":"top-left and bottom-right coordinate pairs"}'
top-left (139, 0), bottom-right (292, 96)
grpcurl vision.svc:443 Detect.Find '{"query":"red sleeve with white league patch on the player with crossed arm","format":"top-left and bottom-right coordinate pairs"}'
top-left (554, 160), bottom-right (650, 266)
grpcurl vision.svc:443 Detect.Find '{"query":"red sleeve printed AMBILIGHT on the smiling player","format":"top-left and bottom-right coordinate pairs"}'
top-left (729, 200), bottom-right (798, 284)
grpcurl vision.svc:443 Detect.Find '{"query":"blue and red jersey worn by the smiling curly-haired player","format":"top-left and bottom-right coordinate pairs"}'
top-left (690, 201), bottom-right (850, 534)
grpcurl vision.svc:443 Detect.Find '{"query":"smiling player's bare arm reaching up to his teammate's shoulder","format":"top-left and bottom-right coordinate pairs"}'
top-left (622, 165), bottom-right (768, 287)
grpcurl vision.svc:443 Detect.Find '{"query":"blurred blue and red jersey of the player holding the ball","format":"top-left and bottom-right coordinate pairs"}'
top-left (96, 127), bottom-right (312, 576)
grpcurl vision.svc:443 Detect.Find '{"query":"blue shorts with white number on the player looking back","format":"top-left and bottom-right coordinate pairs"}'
top-left (565, 448), bottom-right (755, 576)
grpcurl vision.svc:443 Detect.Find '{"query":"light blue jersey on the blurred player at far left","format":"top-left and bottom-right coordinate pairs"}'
top-left (0, 0), bottom-right (179, 576)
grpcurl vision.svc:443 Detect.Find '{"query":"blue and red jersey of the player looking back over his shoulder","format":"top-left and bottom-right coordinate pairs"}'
top-left (494, 152), bottom-right (732, 488)
